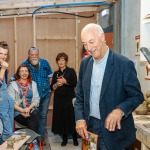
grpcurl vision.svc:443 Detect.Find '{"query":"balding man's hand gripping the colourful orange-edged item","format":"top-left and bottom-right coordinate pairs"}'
top-left (76, 120), bottom-right (88, 139)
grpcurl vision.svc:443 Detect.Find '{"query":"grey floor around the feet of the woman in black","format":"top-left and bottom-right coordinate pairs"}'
top-left (43, 127), bottom-right (81, 150)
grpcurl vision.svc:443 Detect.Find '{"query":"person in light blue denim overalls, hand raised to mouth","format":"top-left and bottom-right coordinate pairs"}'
top-left (0, 41), bottom-right (14, 143)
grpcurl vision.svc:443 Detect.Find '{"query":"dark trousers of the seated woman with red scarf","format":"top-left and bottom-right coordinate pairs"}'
top-left (15, 109), bottom-right (39, 133)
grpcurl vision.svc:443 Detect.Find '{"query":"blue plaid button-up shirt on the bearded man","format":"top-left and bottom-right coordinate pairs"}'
top-left (23, 58), bottom-right (52, 98)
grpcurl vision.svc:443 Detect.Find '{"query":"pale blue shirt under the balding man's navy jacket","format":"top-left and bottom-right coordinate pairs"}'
top-left (90, 49), bottom-right (109, 119)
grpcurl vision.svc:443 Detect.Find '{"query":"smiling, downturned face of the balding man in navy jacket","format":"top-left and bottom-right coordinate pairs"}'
top-left (81, 30), bottom-right (104, 61)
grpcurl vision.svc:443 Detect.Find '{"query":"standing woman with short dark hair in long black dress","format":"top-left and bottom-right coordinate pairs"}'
top-left (51, 53), bottom-right (78, 146)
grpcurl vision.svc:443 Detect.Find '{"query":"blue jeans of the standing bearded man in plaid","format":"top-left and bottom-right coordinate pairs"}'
top-left (38, 92), bottom-right (50, 136)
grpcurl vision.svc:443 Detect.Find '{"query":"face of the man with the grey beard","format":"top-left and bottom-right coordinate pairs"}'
top-left (28, 50), bottom-right (39, 65)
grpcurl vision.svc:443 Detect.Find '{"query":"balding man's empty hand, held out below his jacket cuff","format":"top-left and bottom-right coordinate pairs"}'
top-left (105, 108), bottom-right (123, 131)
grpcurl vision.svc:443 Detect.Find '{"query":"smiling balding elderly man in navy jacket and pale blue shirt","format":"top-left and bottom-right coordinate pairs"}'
top-left (74, 23), bottom-right (144, 150)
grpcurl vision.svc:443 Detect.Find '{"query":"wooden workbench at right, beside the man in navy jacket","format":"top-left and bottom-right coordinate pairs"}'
top-left (133, 115), bottom-right (150, 150)
